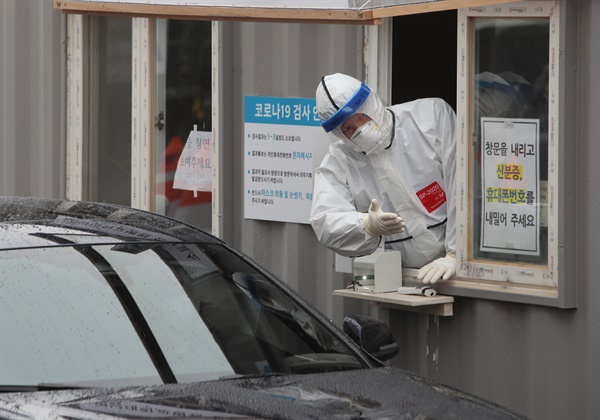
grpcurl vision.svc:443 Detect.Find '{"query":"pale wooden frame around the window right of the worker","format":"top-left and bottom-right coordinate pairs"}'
top-left (440, 1), bottom-right (576, 308)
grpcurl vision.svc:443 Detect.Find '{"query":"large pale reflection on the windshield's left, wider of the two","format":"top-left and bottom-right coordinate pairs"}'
top-left (0, 248), bottom-right (161, 385)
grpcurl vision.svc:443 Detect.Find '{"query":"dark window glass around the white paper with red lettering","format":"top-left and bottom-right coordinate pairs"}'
top-left (156, 20), bottom-right (212, 230)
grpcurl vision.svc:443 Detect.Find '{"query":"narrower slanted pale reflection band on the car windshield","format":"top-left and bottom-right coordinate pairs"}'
top-left (93, 246), bottom-right (234, 382)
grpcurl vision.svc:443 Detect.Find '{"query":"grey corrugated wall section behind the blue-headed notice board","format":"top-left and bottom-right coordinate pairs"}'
top-left (222, 23), bottom-right (363, 320)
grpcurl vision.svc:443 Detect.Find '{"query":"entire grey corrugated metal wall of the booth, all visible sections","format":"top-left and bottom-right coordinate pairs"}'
top-left (0, 0), bottom-right (600, 419)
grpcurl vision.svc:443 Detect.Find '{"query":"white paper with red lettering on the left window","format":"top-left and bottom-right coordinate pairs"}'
top-left (173, 126), bottom-right (212, 192)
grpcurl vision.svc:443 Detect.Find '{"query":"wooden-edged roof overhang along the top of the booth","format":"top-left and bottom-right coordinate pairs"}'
top-left (54, 0), bottom-right (514, 25)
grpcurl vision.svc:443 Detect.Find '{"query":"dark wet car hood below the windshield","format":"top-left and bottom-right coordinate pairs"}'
top-left (0, 367), bottom-right (523, 420)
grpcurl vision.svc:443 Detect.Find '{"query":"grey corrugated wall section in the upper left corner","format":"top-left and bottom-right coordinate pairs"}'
top-left (0, 0), bottom-right (66, 197)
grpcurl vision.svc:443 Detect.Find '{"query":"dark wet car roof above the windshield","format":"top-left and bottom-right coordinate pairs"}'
top-left (0, 196), bottom-right (222, 249)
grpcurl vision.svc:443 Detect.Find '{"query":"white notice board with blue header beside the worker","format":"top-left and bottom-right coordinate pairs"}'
top-left (244, 96), bottom-right (331, 223)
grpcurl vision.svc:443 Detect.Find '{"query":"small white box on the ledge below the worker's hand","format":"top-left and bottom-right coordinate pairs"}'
top-left (353, 251), bottom-right (402, 293)
